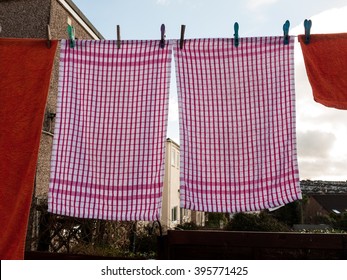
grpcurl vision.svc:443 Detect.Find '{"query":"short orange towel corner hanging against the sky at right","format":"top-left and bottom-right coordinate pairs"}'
top-left (299, 33), bottom-right (347, 109)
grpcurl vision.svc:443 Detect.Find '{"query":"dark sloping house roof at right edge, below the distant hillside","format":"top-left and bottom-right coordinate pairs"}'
top-left (312, 194), bottom-right (347, 213)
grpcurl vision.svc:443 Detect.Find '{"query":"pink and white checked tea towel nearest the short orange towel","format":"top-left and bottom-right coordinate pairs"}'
top-left (174, 37), bottom-right (301, 213)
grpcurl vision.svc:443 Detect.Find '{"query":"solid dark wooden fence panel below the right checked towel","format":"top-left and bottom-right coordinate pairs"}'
top-left (158, 231), bottom-right (347, 260)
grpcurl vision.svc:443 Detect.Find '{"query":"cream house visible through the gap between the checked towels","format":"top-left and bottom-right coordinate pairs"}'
top-left (161, 138), bottom-right (205, 229)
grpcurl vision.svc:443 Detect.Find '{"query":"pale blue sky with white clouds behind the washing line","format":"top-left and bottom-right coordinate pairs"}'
top-left (73, 0), bottom-right (347, 181)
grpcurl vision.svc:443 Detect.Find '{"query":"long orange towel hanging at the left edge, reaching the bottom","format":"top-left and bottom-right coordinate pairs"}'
top-left (0, 39), bottom-right (57, 260)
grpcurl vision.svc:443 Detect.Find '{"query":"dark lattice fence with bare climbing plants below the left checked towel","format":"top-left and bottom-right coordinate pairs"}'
top-left (25, 199), bottom-right (161, 259)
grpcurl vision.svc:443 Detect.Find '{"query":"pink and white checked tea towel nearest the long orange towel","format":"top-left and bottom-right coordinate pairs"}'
top-left (49, 40), bottom-right (172, 221)
